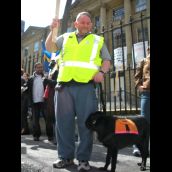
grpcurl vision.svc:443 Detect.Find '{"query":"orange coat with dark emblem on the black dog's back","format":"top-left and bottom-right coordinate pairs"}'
top-left (114, 119), bottom-right (139, 134)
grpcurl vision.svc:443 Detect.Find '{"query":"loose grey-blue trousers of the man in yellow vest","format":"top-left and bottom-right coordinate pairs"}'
top-left (54, 83), bottom-right (97, 161)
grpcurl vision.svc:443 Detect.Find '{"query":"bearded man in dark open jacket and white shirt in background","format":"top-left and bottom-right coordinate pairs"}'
top-left (28, 62), bottom-right (53, 141)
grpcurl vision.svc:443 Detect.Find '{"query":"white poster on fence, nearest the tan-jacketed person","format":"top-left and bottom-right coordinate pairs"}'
top-left (132, 41), bottom-right (148, 68)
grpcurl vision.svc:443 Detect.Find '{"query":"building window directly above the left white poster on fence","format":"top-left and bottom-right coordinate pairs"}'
top-left (113, 29), bottom-right (126, 48)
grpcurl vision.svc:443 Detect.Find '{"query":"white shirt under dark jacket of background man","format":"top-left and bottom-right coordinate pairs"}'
top-left (33, 74), bottom-right (44, 103)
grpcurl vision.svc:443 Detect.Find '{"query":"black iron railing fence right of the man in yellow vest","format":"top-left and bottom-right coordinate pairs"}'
top-left (96, 13), bottom-right (149, 115)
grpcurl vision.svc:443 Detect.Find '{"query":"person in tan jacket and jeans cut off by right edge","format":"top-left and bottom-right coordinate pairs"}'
top-left (133, 47), bottom-right (150, 156)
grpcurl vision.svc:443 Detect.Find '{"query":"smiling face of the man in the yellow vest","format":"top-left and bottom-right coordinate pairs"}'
top-left (74, 15), bottom-right (92, 35)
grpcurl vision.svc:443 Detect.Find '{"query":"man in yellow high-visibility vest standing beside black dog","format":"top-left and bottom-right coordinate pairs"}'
top-left (45, 12), bottom-right (111, 171)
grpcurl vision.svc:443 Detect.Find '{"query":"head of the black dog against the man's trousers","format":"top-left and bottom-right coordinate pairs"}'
top-left (85, 111), bottom-right (104, 131)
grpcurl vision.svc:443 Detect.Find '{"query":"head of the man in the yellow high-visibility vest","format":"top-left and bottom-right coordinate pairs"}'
top-left (74, 12), bottom-right (92, 35)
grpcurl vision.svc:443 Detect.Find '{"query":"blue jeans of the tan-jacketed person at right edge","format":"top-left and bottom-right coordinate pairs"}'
top-left (140, 91), bottom-right (150, 124)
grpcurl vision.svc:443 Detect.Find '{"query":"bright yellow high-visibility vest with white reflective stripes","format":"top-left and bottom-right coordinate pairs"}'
top-left (57, 32), bottom-right (104, 83)
